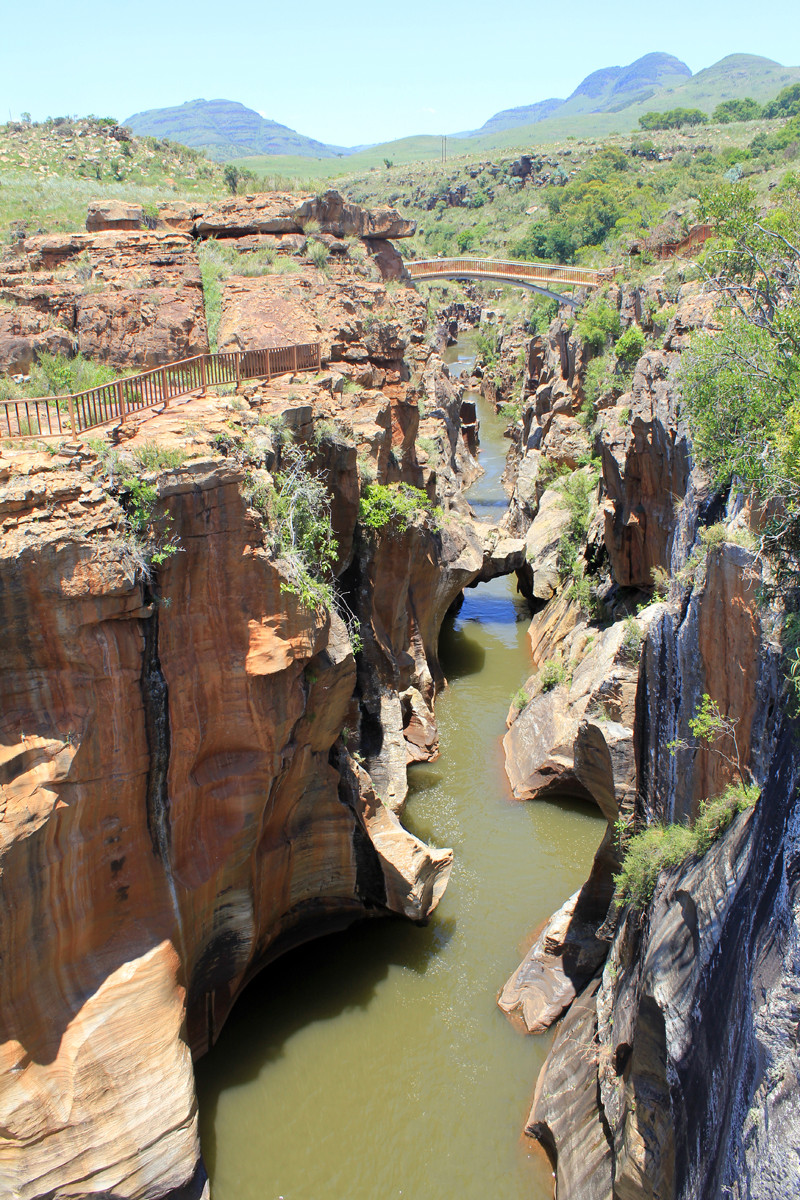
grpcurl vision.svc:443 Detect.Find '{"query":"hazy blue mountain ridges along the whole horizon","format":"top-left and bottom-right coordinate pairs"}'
top-left (125, 52), bottom-right (800, 162)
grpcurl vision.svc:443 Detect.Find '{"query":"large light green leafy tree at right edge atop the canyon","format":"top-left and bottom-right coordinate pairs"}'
top-left (680, 184), bottom-right (800, 595)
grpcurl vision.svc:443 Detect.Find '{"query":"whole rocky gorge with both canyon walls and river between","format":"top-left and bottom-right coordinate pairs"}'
top-left (0, 177), bottom-right (799, 1200)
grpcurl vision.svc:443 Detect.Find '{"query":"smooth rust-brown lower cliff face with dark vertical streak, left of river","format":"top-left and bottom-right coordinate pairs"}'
top-left (0, 410), bottom-right (470, 1200)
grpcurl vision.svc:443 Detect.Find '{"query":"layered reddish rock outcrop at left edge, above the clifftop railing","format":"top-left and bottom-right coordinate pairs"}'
top-left (0, 229), bottom-right (209, 373)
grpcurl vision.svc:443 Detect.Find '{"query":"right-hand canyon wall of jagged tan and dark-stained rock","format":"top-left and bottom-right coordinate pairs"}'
top-left (499, 280), bottom-right (800, 1200)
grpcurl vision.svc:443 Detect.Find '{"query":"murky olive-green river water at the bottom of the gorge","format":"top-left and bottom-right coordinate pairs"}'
top-left (197, 343), bottom-right (602, 1200)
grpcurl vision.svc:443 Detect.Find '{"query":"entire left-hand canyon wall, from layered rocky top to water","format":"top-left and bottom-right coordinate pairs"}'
top-left (0, 197), bottom-right (522, 1200)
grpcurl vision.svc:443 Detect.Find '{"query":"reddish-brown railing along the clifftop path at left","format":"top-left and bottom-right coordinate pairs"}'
top-left (0, 342), bottom-right (323, 439)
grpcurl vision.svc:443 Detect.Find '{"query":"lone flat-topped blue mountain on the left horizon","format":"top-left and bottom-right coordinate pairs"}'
top-left (125, 100), bottom-right (350, 162)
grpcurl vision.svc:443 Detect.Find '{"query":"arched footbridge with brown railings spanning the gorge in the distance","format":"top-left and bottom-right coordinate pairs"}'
top-left (405, 258), bottom-right (621, 307)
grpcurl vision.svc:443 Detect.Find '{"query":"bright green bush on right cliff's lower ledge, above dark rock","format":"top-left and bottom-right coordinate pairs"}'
top-left (614, 785), bottom-right (760, 908)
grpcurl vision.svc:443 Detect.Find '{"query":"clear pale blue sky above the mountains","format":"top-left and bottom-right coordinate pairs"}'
top-left (0, 0), bottom-right (800, 145)
